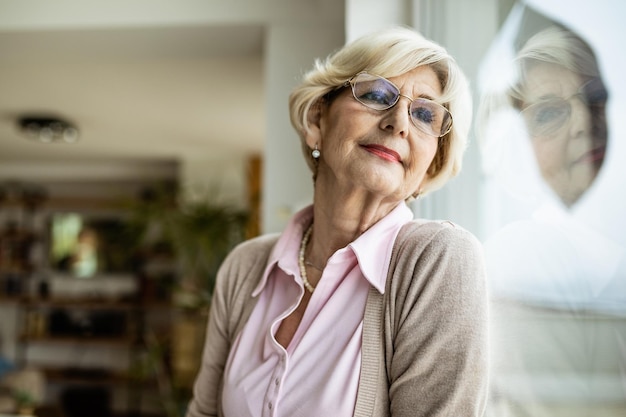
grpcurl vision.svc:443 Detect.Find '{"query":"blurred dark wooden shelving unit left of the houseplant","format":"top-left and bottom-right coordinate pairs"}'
top-left (0, 183), bottom-right (173, 417)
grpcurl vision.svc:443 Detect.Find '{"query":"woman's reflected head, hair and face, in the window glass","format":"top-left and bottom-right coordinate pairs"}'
top-left (509, 26), bottom-right (608, 207)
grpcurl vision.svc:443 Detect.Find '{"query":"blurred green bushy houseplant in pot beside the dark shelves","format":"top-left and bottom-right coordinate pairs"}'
top-left (131, 185), bottom-right (249, 309)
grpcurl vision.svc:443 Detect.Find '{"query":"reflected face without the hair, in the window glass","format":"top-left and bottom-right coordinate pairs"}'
top-left (522, 64), bottom-right (606, 206)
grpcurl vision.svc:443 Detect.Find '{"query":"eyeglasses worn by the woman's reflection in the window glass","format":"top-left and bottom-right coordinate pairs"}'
top-left (522, 78), bottom-right (608, 137)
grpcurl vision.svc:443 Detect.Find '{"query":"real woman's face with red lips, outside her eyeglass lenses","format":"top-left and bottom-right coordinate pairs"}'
top-left (307, 66), bottom-right (441, 201)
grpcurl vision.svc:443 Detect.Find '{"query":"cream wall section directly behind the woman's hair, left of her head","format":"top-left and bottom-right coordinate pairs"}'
top-left (262, 21), bottom-right (344, 233)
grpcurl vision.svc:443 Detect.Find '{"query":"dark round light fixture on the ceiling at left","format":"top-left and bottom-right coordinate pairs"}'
top-left (18, 116), bottom-right (78, 143)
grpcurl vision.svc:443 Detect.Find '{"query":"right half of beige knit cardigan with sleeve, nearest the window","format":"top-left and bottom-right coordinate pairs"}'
top-left (355, 222), bottom-right (488, 417)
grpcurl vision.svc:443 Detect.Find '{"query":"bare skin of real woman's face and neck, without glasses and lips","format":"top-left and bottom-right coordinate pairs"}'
top-left (305, 66), bottom-right (441, 274)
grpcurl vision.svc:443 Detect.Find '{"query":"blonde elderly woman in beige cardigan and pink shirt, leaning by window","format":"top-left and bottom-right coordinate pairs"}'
top-left (187, 28), bottom-right (487, 417)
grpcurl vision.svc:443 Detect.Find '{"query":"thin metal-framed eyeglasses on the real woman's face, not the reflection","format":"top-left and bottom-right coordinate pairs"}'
top-left (345, 72), bottom-right (452, 138)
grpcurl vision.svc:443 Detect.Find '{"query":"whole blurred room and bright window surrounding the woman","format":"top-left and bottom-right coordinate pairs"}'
top-left (0, 0), bottom-right (626, 417)
